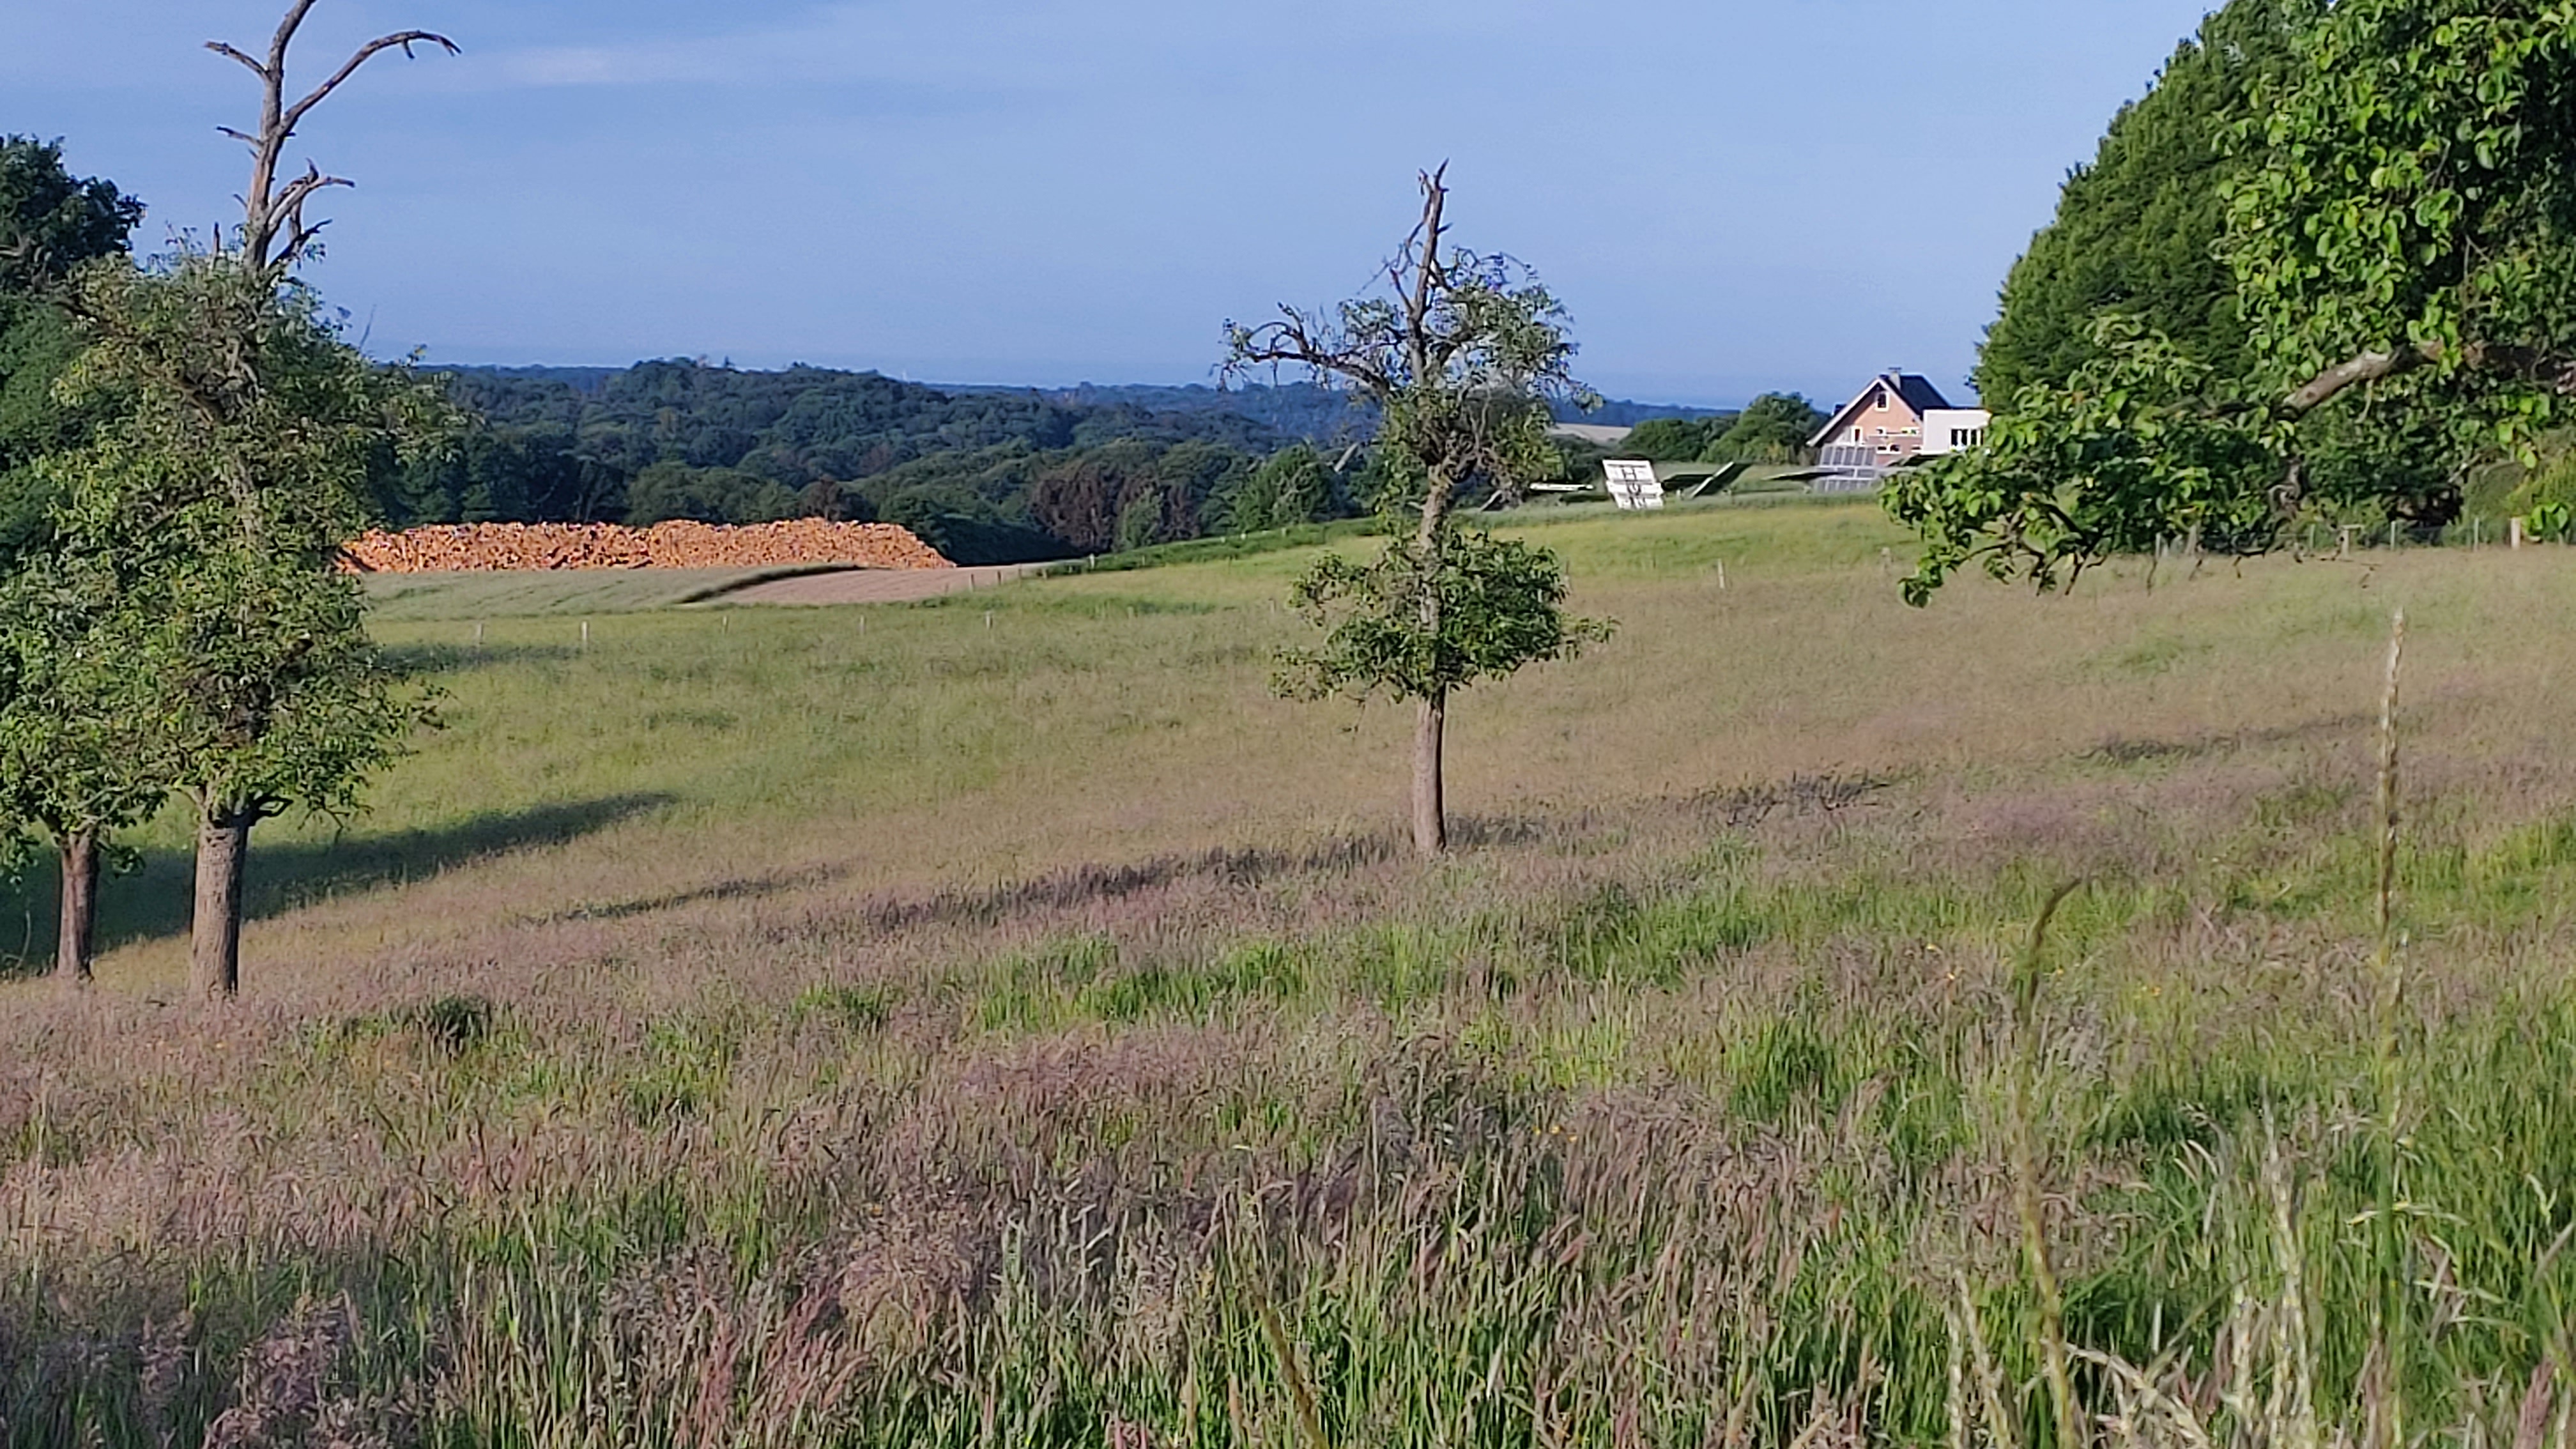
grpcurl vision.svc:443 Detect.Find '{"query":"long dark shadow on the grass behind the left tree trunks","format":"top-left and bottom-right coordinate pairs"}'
top-left (0, 794), bottom-right (675, 977)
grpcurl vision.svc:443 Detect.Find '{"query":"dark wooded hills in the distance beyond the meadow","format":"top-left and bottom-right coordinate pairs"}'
top-left (376, 361), bottom-right (1715, 562)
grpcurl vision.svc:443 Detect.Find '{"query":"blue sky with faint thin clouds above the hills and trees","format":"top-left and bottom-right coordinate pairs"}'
top-left (0, 0), bottom-right (2205, 405)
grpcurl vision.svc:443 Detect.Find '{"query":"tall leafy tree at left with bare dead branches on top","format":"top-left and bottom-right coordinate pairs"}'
top-left (49, 0), bottom-right (456, 998)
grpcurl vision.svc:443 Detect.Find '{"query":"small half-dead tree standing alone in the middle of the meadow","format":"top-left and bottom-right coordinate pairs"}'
top-left (1226, 167), bottom-right (1607, 856)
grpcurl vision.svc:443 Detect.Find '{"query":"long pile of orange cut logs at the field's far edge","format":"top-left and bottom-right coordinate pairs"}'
top-left (345, 518), bottom-right (956, 572)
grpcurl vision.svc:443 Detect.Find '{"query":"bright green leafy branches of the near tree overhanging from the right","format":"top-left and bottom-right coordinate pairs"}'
top-left (1888, 0), bottom-right (2576, 601)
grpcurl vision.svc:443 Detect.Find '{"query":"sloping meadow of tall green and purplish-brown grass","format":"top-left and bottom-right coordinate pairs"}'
top-left (0, 505), bottom-right (2576, 1449)
